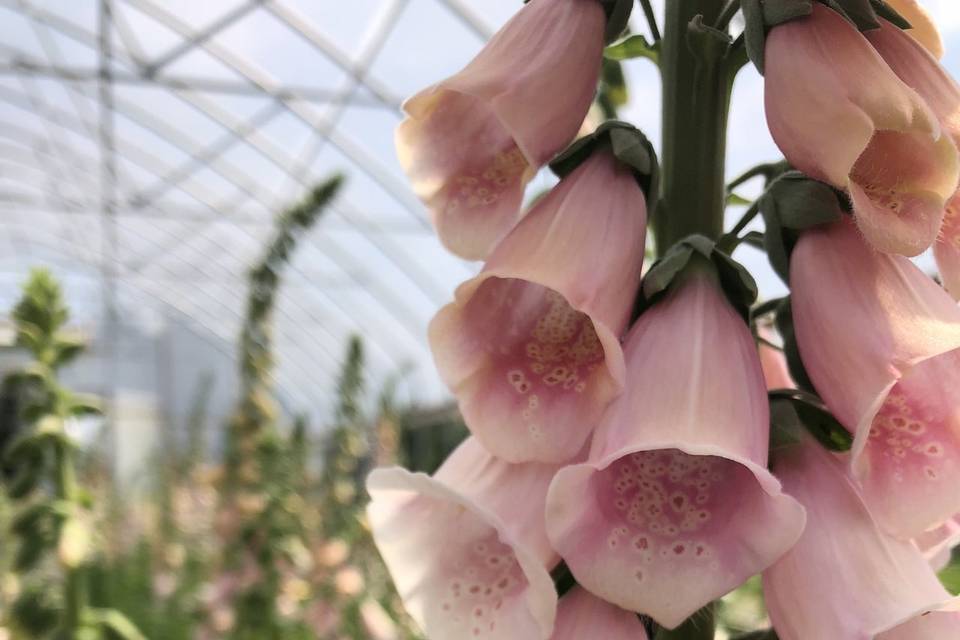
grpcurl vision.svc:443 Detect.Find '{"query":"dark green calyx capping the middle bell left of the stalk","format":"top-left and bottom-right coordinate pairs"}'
top-left (550, 120), bottom-right (660, 216)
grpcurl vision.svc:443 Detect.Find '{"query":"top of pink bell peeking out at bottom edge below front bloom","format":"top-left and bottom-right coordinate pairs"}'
top-left (550, 587), bottom-right (647, 640)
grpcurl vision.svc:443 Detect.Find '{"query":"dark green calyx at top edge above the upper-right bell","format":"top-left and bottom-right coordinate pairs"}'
top-left (742, 0), bottom-right (910, 74)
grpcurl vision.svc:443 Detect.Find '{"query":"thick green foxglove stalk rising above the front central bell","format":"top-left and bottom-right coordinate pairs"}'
top-left (653, 0), bottom-right (730, 255)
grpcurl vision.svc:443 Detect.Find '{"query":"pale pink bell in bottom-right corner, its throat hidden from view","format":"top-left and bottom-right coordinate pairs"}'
top-left (763, 434), bottom-right (960, 640)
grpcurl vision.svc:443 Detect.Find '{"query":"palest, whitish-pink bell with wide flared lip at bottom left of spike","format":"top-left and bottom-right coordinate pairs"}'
top-left (367, 438), bottom-right (558, 640)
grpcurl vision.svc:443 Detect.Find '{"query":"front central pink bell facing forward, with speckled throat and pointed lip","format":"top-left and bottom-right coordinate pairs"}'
top-left (547, 265), bottom-right (804, 628)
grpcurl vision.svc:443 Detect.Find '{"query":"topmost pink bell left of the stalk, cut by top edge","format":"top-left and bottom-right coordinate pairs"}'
top-left (396, 0), bottom-right (606, 259)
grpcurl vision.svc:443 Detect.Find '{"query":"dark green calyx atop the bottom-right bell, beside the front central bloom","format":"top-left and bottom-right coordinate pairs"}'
top-left (769, 389), bottom-right (853, 452)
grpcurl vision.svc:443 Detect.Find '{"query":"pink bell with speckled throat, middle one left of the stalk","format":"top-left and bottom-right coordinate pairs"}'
top-left (429, 150), bottom-right (646, 462)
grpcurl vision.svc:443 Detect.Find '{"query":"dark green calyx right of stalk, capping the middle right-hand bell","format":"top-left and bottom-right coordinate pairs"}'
top-left (759, 171), bottom-right (850, 283)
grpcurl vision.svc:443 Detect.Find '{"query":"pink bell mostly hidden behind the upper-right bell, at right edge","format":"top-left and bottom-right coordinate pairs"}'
top-left (867, 22), bottom-right (960, 298)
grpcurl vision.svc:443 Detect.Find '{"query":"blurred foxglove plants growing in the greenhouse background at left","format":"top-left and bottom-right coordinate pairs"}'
top-left (0, 176), bottom-right (465, 640)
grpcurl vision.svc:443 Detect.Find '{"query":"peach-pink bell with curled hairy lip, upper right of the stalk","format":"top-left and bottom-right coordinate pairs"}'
top-left (764, 2), bottom-right (960, 256)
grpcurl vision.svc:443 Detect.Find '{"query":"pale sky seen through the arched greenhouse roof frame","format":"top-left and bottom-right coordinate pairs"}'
top-left (0, 0), bottom-right (960, 418)
